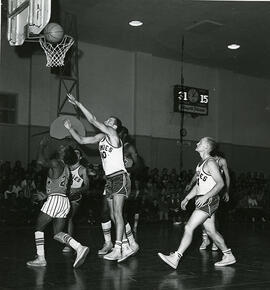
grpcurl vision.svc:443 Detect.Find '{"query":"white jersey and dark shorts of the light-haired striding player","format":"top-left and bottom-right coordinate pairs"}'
top-left (196, 157), bottom-right (219, 216)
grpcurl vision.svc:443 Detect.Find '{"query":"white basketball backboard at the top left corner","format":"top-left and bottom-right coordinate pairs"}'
top-left (7, 0), bottom-right (51, 46)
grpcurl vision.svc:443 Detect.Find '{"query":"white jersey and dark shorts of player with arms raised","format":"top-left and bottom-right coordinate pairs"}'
top-left (99, 136), bottom-right (130, 198)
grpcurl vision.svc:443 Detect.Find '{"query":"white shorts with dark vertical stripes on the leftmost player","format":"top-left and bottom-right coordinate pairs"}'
top-left (41, 194), bottom-right (70, 218)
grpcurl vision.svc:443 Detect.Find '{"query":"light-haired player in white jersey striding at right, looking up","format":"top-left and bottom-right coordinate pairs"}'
top-left (158, 137), bottom-right (236, 269)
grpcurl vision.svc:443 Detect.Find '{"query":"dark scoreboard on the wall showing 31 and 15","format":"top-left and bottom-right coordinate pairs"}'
top-left (173, 85), bottom-right (209, 115)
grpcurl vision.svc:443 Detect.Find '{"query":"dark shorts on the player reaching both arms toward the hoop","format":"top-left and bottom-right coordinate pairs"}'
top-left (105, 172), bottom-right (131, 198)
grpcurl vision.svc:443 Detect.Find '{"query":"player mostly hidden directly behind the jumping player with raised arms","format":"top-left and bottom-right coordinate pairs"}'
top-left (98, 126), bottom-right (139, 255)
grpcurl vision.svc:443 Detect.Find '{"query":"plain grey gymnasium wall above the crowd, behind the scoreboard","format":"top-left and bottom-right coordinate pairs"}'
top-left (0, 39), bottom-right (270, 172)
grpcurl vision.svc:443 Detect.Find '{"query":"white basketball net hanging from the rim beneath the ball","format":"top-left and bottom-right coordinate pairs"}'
top-left (39, 35), bottom-right (74, 67)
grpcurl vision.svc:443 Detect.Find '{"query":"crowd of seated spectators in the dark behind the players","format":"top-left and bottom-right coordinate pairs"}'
top-left (0, 161), bottom-right (270, 225)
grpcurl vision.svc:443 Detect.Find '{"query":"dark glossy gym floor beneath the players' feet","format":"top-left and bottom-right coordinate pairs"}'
top-left (0, 223), bottom-right (270, 290)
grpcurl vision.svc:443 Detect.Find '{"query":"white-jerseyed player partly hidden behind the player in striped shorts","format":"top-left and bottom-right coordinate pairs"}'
top-left (63, 149), bottom-right (89, 253)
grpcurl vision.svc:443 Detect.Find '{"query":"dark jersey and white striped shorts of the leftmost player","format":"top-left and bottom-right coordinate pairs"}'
top-left (41, 165), bottom-right (70, 218)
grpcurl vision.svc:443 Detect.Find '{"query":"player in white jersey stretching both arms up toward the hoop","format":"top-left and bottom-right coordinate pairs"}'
top-left (64, 94), bottom-right (134, 262)
